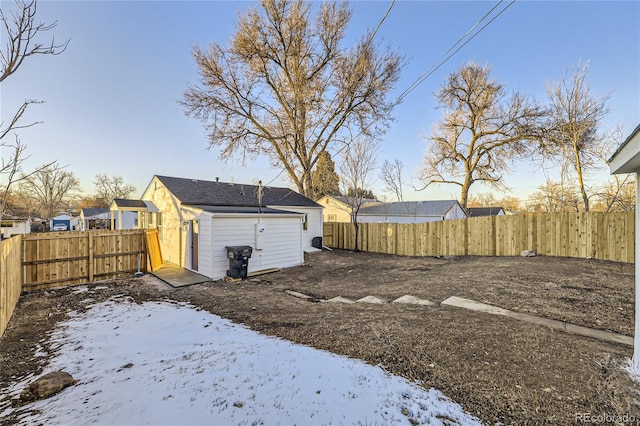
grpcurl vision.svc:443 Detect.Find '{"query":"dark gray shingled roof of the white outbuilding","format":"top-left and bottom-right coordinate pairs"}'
top-left (156, 176), bottom-right (321, 207)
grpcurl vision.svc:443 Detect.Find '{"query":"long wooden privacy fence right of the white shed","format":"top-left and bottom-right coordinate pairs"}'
top-left (323, 212), bottom-right (635, 263)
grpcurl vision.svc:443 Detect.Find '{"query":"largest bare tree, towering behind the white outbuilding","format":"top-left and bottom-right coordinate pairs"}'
top-left (181, 0), bottom-right (401, 197)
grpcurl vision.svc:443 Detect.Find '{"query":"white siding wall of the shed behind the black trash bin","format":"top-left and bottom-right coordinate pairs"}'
top-left (209, 216), bottom-right (304, 279)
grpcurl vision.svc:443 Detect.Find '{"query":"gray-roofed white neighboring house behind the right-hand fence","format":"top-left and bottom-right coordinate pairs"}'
top-left (358, 200), bottom-right (467, 223)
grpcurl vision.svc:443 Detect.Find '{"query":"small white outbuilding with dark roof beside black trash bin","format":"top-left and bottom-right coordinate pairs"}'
top-left (112, 176), bottom-right (322, 279)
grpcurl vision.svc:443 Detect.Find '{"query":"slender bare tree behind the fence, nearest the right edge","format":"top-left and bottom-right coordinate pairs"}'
top-left (545, 65), bottom-right (609, 211)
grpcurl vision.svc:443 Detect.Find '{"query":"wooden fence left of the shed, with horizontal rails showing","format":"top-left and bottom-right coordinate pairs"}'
top-left (0, 229), bottom-right (147, 336)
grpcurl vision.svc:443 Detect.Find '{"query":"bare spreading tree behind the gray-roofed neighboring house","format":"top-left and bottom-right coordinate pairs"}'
top-left (420, 63), bottom-right (545, 208)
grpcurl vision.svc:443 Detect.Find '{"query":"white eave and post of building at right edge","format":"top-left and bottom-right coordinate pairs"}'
top-left (609, 125), bottom-right (640, 374)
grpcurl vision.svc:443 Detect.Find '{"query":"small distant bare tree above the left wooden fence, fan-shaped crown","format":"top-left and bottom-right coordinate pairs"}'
top-left (20, 164), bottom-right (80, 219)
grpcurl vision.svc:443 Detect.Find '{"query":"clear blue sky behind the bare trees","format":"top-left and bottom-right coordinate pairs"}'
top-left (0, 0), bottom-right (640, 200)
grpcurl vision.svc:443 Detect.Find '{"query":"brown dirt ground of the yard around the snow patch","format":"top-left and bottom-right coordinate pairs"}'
top-left (0, 250), bottom-right (640, 424)
